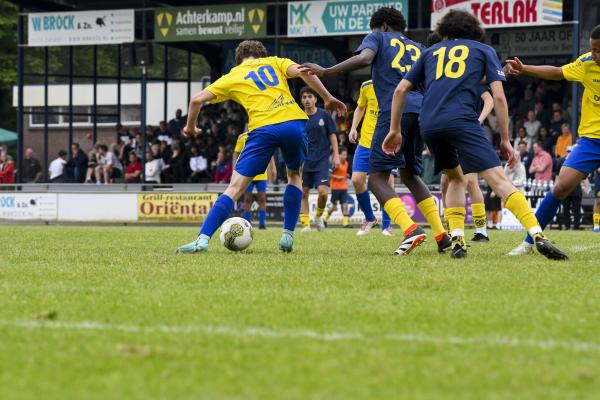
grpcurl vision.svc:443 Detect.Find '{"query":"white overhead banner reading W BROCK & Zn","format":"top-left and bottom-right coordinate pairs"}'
top-left (27, 10), bottom-right (135, 46)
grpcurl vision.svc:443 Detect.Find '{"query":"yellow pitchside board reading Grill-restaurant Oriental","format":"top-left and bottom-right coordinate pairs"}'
top-left (138, 193), bottom-right (219, 222)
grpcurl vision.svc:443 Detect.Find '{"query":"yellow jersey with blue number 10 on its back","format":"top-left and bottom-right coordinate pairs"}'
top-left (206, 57), bottom-right (308, 132)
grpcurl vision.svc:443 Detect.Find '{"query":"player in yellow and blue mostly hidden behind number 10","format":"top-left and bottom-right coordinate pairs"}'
top-left (233, 132), bottom-right (277, 229)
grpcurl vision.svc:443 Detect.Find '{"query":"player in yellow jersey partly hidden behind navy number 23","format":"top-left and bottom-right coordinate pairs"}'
top-left (348, 79), bottom-right (394, 236)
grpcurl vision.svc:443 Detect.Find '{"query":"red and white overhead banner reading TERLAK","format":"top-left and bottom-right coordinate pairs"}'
top-left (431, 0), bottom-right (563, 29)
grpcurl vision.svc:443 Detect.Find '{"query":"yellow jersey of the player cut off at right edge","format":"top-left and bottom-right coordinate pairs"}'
top-left (562, 53), bottom-right (600, 139)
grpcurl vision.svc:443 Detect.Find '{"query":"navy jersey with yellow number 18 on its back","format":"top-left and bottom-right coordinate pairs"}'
top-left (406, 39), bottom-right (506, 133)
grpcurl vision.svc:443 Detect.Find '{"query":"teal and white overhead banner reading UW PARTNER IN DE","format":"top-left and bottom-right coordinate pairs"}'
top-left (288, 0), bottom-right (408, 37)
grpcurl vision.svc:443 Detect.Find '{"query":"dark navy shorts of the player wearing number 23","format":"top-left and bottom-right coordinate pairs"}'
top-left (369, 113), bottom-right (423, 175)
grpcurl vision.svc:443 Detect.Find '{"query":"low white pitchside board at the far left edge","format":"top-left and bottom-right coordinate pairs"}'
top-left (0, 192), bottom-right (58, 221)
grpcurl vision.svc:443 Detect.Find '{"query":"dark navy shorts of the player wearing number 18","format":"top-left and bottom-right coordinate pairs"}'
top-left (423, 124), bottom-right (501, 174)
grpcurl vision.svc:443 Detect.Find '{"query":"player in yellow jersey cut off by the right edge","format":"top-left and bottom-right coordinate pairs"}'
top-left (506, 25), bottom-right (600, 256)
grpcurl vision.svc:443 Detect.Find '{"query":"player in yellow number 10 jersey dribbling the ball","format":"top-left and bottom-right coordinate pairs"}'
top-left (177, 40), bottom-right (346, 253)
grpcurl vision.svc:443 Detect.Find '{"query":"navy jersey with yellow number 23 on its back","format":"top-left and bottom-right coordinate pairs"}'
top-left (356, 32), bottom-right (425, 114)
